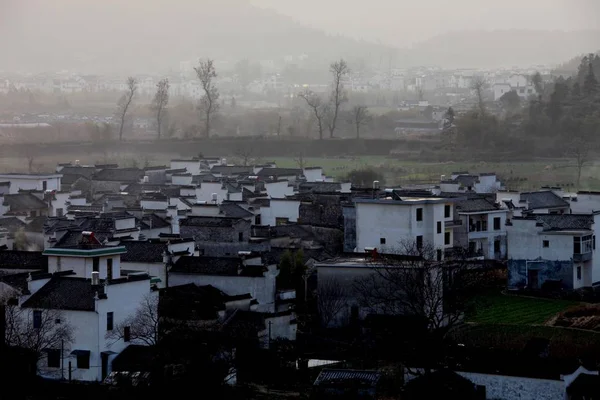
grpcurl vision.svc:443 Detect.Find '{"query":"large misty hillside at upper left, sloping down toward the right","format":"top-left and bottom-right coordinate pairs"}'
top-left (0, 0), bottom-right (390, 72)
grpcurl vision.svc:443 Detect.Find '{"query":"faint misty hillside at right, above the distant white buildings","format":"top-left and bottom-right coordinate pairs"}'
top-left (410, 30), bottom-right (600, 67)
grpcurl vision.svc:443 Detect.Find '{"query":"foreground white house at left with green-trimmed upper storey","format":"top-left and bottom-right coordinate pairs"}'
top-left (13, 235), bottom-right (156, 381)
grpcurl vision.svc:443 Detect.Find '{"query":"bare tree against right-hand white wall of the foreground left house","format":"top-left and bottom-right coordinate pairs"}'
top-left (106, 293), bottom-right (159, 346)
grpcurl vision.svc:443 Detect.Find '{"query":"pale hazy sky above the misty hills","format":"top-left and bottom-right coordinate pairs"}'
top-left (251, 0), bottom-right (600, 46)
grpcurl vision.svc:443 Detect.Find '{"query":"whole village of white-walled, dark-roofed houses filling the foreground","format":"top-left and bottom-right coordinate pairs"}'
top-left (0, 157), bottom-right (600, 399)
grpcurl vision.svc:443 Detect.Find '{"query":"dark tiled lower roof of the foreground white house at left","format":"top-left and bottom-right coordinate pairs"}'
top-left (22, 277), bottom-right (102, 311)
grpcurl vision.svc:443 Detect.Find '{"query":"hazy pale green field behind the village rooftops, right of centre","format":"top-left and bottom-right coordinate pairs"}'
top-left (265, 156), bottom-right (600, 191)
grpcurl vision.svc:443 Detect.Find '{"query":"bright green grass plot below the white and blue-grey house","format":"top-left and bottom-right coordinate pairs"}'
top-left (468, 294), bottom-right (578, 325)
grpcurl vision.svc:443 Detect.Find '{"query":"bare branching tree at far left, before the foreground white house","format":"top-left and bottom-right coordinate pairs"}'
top-left (4, 304), bottom-right (74, 372)
